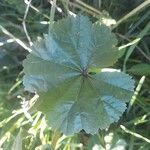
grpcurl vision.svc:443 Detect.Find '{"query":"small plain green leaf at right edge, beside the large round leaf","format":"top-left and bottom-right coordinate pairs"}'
top-left (128, 64), bottom-right (150, 76)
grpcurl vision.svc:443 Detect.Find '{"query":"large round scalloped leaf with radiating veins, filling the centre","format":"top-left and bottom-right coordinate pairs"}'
top-left (23, 15), bottom-right (134, 134)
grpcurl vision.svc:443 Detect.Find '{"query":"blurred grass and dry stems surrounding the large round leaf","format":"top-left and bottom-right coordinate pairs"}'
top-left (0, 0), bottom-right (150, 150)
